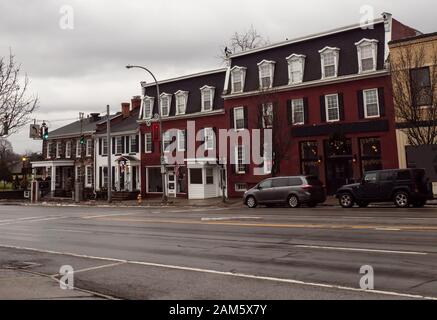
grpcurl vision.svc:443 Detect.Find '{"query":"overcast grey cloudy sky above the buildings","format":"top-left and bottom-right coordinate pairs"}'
top-left (0, 0), bottom-right (437, 152)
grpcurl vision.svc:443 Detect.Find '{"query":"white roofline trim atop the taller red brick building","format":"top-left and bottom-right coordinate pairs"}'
top-left (229, 18), bottom-right (384, 59)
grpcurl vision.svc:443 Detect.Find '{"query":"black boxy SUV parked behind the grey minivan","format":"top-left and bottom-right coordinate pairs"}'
top-left (336, 169), bottom-right (433, 208)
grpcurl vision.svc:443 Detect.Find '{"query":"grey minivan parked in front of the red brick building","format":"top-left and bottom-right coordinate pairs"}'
top-left (244, 176), bottom-right (326, 208)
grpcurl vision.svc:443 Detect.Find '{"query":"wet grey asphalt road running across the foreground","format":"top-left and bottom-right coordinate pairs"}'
top-left (0, 205), bottom-right (437, 299)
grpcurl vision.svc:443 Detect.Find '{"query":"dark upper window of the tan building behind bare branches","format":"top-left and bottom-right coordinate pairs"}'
top-left (410, 67), bottom-right (432, 107)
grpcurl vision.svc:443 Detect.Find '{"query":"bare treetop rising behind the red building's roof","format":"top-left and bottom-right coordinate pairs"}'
top-left (219, 25), bottom-right (269, 63)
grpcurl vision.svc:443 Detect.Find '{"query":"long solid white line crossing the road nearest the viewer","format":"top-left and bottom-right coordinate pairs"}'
top-left (0, 245), bottom-right (437, 300)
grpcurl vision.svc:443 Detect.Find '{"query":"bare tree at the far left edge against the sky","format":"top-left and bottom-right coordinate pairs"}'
top-left (0, 52), bottom-right (38, 136)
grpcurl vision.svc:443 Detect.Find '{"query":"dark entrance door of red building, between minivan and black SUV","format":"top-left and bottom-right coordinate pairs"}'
top-left (326, 158), bottom-right (353, 194)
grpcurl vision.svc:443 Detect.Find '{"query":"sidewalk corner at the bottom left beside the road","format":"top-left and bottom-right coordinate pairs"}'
top-left (0, 268), bottom-right (103, 300)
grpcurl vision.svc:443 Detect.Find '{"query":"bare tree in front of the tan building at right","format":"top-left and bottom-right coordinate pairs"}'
top-left (390, 46), bottom-right (437, 146)
